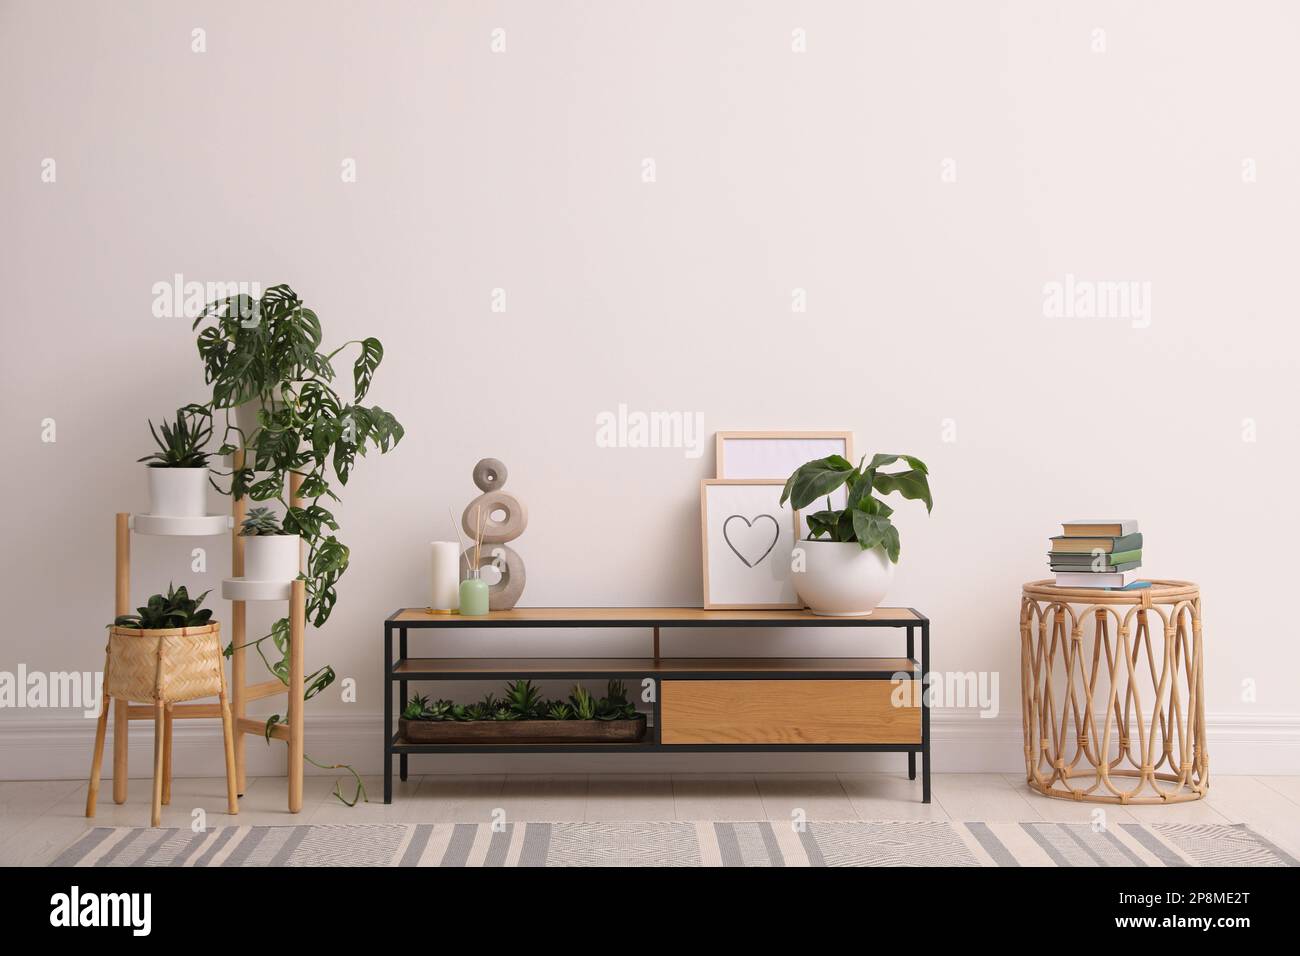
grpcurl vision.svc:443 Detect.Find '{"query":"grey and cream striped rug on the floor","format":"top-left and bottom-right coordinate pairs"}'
top-left (53, 821), bottom-right (1296, 866)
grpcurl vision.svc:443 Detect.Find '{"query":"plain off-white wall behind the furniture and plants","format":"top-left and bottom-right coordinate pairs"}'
top-left (0, 0), bottom-right (1300, 775)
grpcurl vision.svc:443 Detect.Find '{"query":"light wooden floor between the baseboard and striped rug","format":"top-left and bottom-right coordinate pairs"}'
top-left (0, 774), bottom-right (1300, 866)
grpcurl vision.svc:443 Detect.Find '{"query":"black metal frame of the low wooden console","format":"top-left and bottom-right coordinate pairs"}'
top-left (384, 607), bottom-right (930, 804)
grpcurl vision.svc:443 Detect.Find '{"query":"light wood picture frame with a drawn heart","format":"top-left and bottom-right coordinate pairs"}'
top-left (699, 479), bottom-right (803, 610)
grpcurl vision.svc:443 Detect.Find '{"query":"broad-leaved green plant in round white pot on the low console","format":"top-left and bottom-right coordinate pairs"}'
top-left (781, 455), bottom-right (933, 617)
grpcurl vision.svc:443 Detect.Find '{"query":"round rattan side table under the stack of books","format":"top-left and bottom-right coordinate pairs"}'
top-left (1021, 580), bottom-right (1209, 804)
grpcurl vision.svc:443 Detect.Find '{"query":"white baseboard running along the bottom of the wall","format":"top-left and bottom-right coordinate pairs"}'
top-left (0, 710), bottom-right (1300, 780)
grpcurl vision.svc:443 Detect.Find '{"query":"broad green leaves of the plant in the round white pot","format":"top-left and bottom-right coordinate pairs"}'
top-left (781, 455), bottom-right (935, 564)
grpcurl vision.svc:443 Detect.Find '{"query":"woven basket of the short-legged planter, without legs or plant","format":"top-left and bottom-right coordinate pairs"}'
top-left (104, 622), bottom-right (225, 704)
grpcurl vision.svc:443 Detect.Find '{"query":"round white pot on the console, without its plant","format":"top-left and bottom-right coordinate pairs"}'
top-left (793, 541), bottom-right (894, 618)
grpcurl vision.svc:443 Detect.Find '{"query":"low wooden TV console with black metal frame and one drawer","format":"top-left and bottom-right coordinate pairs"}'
top-left (384, 607), bottom-right (930, 804)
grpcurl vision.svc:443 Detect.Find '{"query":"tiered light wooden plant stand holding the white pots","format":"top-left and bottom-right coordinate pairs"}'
top-left (101, 453), bottom-right (307, 817)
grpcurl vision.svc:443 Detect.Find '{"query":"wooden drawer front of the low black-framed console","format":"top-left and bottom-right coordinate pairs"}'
top-left (660, 680), bottom-right (920, 744)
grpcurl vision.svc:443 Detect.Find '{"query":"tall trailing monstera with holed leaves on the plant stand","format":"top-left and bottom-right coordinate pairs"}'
top-left (194, 285), bottom-right (403, 801)
